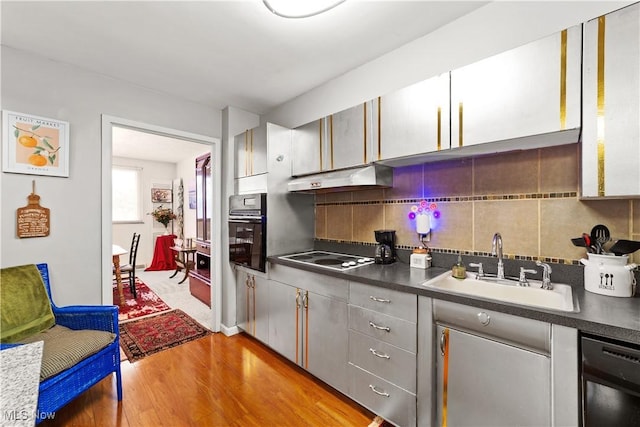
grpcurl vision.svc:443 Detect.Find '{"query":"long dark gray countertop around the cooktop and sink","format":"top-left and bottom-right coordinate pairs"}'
top-left (268, 257), bottom-right (640, 344)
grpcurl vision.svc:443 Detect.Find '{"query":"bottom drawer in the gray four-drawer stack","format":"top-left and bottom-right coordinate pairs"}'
top-left (349, 364), bottom-right (417, 427)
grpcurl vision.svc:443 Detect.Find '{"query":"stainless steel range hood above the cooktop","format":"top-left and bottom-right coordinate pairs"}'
top-left (287, 164), bottom-right (393, 193)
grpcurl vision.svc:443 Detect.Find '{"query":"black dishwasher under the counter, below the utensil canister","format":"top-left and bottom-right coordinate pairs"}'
top-left (581, 335), bottom-right (640, 427)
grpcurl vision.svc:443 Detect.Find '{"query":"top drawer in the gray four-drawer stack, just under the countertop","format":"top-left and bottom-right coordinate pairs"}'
top-left (349, 282), bottom-right (418, 322)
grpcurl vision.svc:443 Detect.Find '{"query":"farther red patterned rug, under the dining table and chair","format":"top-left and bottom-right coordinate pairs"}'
top-left (113, 277), bottom-right (171, 323)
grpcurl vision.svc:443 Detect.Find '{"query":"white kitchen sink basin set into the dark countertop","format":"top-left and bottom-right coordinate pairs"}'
top-left (423, 272), bottom-right (578, 312)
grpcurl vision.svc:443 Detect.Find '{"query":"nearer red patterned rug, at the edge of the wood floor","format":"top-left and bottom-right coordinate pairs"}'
top-left (120, 310), bottom-right (212, 363)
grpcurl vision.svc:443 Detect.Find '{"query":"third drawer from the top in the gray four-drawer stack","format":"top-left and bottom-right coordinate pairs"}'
top-left (349, 331), bottom-right (416, 393)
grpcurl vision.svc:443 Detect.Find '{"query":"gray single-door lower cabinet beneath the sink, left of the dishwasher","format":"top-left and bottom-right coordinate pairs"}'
top-left (434, 301), bottom-right (552, 427)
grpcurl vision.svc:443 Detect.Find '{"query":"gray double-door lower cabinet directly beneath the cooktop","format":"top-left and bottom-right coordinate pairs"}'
top-left (269, 266), bottom-right (348, 393)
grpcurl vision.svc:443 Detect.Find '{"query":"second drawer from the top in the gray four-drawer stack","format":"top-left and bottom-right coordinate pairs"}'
top-left (349, 305), bottom-right (417, 353)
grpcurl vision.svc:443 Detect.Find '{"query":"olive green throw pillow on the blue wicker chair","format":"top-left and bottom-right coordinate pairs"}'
top-left (0, 264), bottom-right (56, 343)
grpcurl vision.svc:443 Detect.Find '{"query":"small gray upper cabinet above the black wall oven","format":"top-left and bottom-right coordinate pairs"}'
top-left (234, 124), bottom-right (267, 178)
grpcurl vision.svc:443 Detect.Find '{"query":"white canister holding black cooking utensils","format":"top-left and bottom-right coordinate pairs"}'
top-left (580, 253), bottom-right (637, 297)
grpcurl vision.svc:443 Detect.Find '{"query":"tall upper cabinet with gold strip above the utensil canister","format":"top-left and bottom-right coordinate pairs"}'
top-left (582, 3), bottom-right (640, 197)
